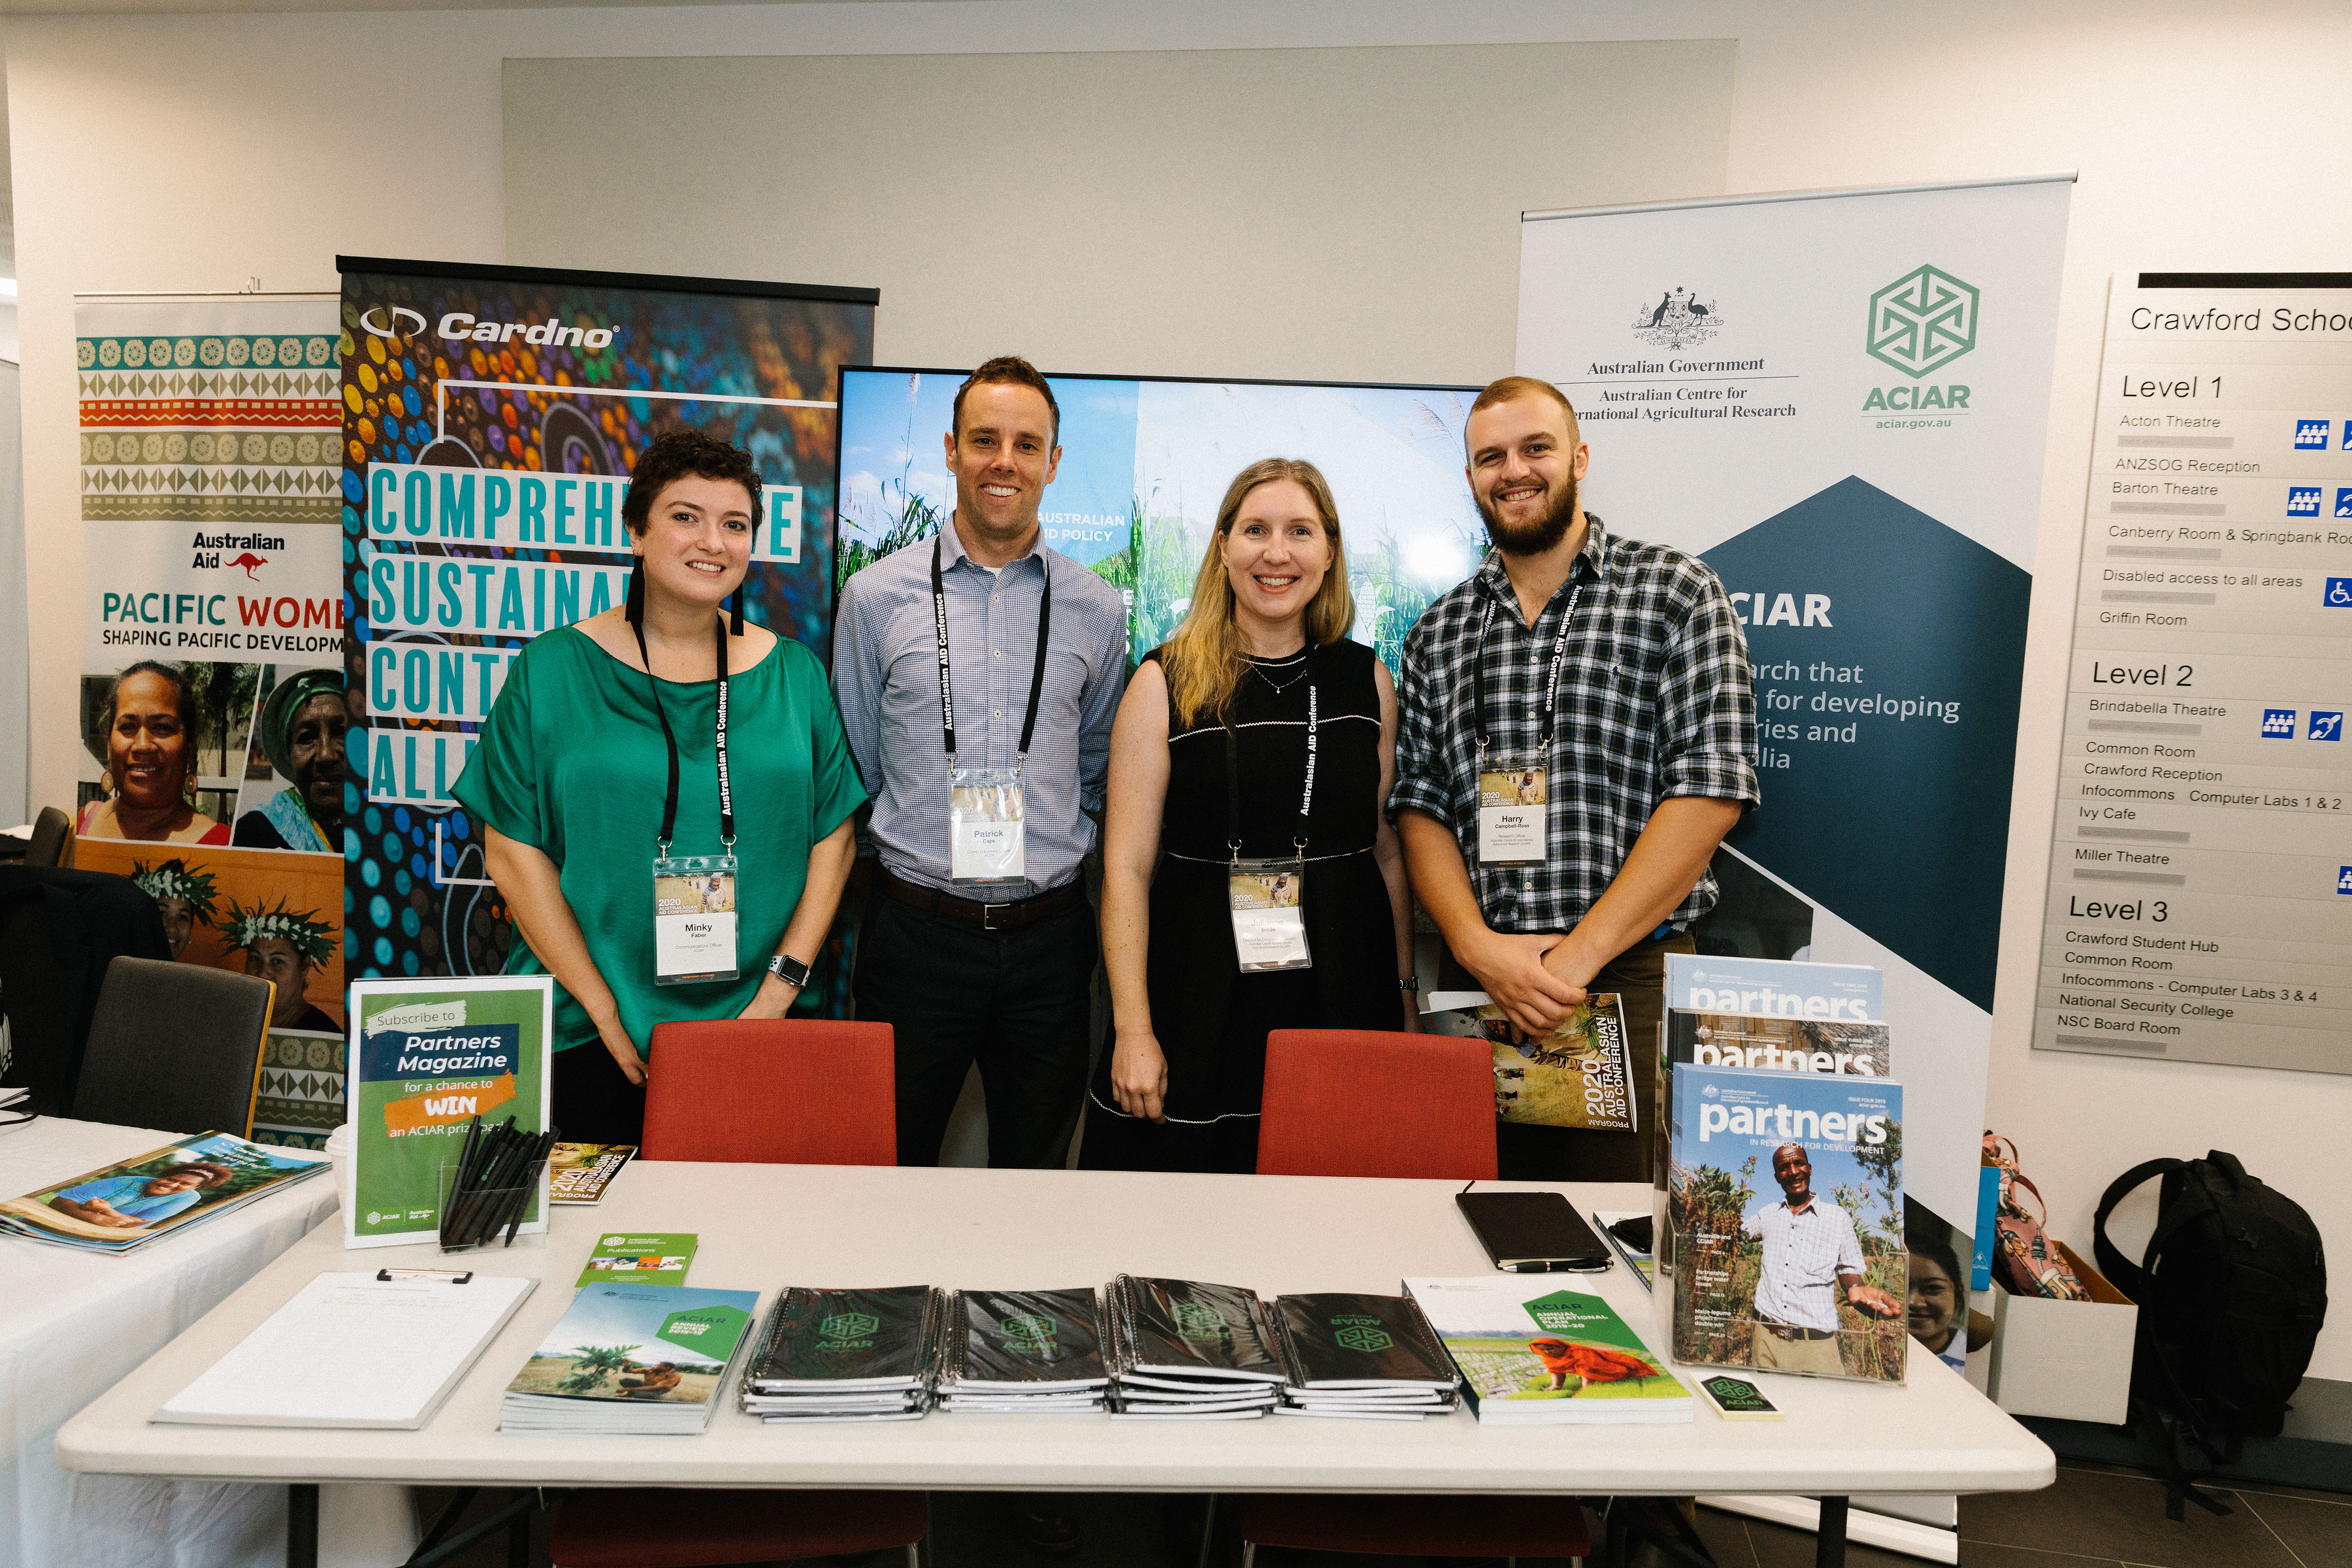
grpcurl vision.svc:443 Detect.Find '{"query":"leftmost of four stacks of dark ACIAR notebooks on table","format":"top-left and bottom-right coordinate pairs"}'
top-left (743, 1286), bottom-right (945, 1422)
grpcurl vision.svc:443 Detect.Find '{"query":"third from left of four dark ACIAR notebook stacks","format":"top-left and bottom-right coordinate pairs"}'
top-left (1108, 1274), bottom-right (1289, 1420)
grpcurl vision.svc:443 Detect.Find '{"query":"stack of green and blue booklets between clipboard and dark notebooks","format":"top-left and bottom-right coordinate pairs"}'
top-left (498, 1284), bottom-right (760, 1437)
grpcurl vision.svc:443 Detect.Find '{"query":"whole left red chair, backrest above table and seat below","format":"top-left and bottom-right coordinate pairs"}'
top-left (548, 1018), bottom-right (932, 1568)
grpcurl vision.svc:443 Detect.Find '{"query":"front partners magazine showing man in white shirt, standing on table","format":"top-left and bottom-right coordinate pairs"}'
top-left (1663, 1065), bottom-right (1910, 1382)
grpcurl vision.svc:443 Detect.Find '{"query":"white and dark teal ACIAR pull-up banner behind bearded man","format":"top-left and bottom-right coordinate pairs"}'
top-left (1520, 176), bottom-right (2072, 1258)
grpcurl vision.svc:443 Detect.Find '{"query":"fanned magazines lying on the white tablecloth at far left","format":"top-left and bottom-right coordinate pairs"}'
top-left (0, 1133), bottom-right (327, 1253)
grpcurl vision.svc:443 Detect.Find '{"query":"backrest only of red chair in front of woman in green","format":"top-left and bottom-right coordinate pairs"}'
top-left (642, 1018), bottom-right (898, 1166)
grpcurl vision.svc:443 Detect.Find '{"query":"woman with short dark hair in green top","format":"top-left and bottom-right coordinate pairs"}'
top-left (454, 430), bottom-right (866, 1143)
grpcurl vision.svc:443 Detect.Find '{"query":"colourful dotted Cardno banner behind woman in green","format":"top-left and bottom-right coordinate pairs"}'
top-left (338, 256), bottom-right (875, 992)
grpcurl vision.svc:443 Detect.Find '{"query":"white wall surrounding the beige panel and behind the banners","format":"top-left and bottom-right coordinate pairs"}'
top-left (5, 0), bottom-right (2352, 1378)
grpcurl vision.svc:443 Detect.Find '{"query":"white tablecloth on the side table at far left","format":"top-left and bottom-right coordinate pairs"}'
top-left (0, 1117), bottom-right (334, 1568)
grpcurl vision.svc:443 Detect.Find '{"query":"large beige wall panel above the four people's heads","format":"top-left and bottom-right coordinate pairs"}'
top-left (503, 40), bottom-right (1733, 385)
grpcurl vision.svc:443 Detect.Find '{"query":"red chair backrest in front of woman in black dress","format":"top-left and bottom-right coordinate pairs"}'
top-left (1260, 1030), bottom-right (1494, 1183)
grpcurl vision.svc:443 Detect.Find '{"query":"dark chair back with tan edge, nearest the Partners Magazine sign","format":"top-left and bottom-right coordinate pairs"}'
top-left (73, 959), bottom-right (278, 1138)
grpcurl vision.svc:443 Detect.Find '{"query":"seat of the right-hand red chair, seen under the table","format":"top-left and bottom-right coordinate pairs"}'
top-left (1232, 1493), bottom-right (1592, 1568)
